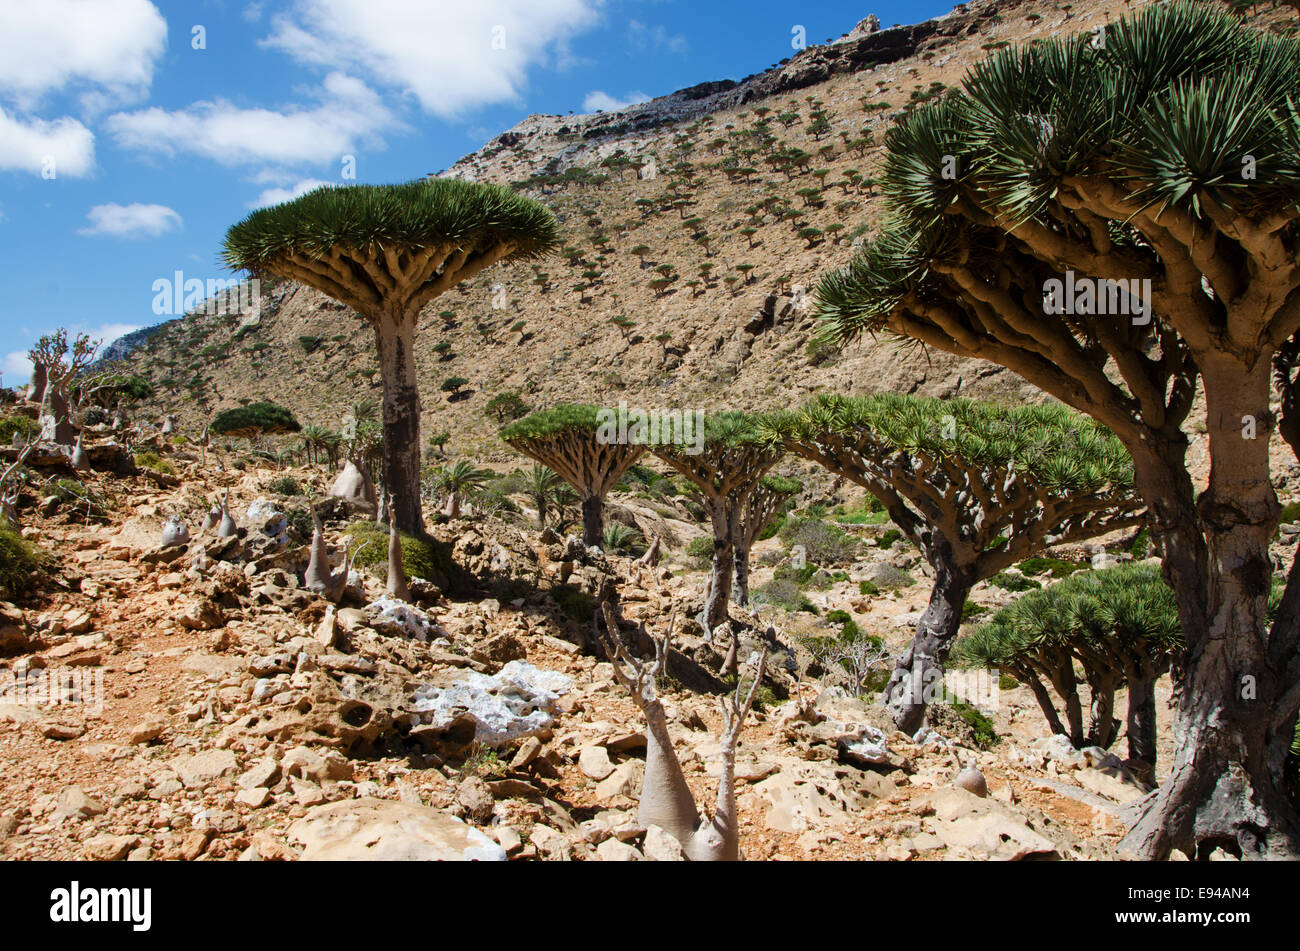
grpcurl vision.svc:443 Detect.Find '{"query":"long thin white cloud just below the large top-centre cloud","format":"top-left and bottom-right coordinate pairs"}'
top-left (104, 73), bottom-right (402, 165)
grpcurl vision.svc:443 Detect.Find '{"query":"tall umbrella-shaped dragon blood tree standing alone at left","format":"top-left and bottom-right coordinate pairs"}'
top-left (224, 178), bottom-right (559, 534)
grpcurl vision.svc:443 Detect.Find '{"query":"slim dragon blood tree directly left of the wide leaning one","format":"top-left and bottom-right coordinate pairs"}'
top-left (654, 412), bottom-right (785, 631)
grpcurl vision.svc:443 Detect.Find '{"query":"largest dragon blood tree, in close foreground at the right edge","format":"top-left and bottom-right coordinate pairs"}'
top-left (819, 1), bottom-right (1300, 859)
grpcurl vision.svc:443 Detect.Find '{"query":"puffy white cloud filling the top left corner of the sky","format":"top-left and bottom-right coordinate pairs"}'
top-left (0, 0), bottom-right (166, 107)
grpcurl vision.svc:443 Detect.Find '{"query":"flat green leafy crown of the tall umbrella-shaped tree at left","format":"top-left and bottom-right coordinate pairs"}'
top-left (224, 178), bottom-right (559, 272)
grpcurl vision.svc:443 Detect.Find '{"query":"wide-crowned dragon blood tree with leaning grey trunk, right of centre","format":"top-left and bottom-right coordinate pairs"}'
top-left (764, 394), bottom-right (1143, 733)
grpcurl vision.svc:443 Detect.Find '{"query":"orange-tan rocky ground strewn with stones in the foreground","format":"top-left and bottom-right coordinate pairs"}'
top-left (0, 415), bottom-right (1216, 860)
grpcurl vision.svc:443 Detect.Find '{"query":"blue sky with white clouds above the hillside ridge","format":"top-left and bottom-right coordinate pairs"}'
top-left (0, 0), bottom-right (952, 386)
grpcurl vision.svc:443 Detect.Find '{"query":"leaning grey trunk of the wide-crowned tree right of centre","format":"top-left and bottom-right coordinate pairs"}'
top-left (884, 542), bottom-right (974, 735)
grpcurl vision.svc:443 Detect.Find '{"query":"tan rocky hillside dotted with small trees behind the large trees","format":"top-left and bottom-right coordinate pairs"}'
top-left (116, 0), bottom-right (1164, 459)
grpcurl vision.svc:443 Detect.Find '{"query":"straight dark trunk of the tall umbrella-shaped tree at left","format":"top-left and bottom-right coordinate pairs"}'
top-left (374, 314), bottom-right (424, 535)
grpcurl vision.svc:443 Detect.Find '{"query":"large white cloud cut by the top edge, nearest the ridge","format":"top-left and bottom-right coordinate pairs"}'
top-left (264, 0), bottom-right (599, 117)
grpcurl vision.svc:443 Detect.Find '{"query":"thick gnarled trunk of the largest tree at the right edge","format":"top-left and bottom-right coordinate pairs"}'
top-left (1121, 356), bottom-right (1300, 859)
